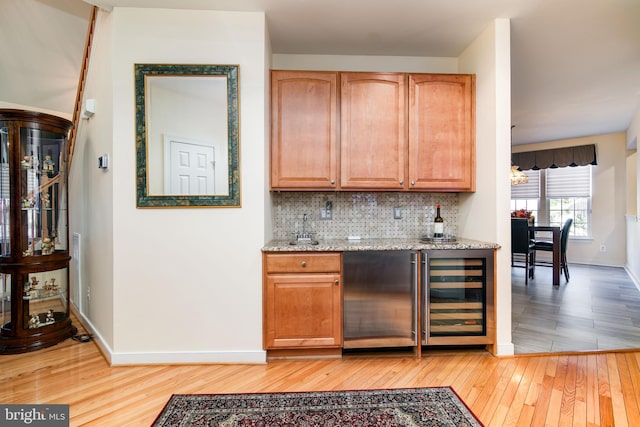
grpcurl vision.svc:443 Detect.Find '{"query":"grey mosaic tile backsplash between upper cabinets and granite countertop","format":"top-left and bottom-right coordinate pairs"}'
top-left (271, 192), bottom-right (458, 240)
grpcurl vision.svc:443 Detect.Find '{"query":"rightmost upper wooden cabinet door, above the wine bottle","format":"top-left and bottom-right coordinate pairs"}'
top-left (409, 74), bottom-right (475, 191)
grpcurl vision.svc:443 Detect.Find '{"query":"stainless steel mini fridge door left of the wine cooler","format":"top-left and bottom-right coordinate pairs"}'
top-left (343, 251), bottom-right (419, 349)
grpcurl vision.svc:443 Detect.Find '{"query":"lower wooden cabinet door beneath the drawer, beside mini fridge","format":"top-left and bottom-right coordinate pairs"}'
top-left (264, 274), bottom-right (342, 349)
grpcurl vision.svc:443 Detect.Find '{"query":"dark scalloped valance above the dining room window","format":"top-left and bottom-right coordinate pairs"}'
top-left (511, 144), bottom-right (598, 170)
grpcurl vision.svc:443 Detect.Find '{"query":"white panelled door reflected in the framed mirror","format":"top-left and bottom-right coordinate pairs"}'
top-left (164, 136), bottom-right (218, 195)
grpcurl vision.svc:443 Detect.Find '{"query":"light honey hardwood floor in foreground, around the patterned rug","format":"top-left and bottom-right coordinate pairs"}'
top-left (0, 320), bottom-right (640, 427)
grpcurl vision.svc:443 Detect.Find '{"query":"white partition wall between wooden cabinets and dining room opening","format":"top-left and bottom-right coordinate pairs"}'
top-left (458, 19), bottom-right (514, 355)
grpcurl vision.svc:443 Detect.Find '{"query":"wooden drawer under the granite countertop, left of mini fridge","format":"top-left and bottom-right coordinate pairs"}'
top-left (266, 253), bottom-right (341, 273)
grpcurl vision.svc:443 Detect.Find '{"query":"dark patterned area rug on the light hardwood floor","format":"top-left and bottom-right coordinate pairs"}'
top-left (153, 387), bottom-right (482, 427)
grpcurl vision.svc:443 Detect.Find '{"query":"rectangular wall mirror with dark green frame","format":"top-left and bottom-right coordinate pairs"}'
top-left (134, 64), bottom-right (240, 208)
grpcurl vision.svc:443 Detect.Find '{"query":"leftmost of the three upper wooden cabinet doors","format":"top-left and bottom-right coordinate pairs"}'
top-left (271, 71), bottom-right (338, 190)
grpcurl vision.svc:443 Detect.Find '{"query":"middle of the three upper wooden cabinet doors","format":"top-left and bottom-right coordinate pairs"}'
top-left (340, 73), bottom-right (407, 190)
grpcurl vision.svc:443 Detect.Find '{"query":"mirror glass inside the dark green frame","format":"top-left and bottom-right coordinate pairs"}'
top-left (145, 75), bottom-right (229, 196)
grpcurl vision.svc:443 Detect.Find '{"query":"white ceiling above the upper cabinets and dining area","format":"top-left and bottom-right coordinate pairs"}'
top-left (0, 0), bottom-right (640, 144)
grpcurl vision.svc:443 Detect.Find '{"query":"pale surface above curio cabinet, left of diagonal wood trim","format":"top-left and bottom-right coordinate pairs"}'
top-left (0, 0), bottom-right (91, 118)
